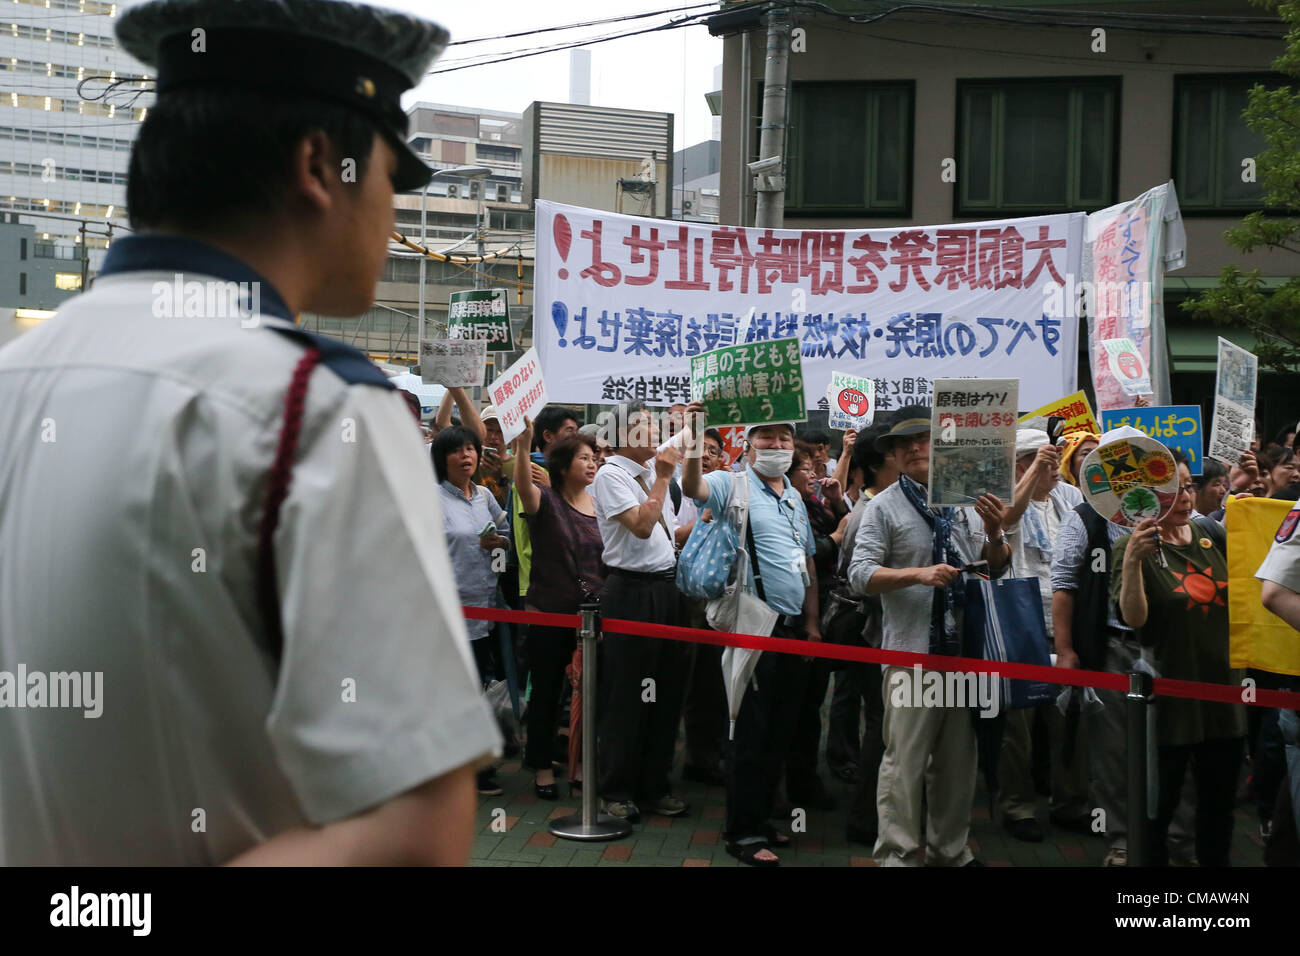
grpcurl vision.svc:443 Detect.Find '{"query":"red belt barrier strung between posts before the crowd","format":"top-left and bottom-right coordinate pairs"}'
top-left (462, 607), bottom-right (1300, 710)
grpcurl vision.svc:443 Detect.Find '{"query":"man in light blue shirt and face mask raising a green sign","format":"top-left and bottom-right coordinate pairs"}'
top-left (681, 405), bottom-right (822, 866)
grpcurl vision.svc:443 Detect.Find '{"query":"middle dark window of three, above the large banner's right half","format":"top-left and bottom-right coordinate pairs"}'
top-left (954, 78), bottom-right (1119, 216)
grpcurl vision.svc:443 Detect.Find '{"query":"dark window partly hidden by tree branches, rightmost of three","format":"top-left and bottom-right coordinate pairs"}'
top-left (1174, 74), bottom-right (1278, 213)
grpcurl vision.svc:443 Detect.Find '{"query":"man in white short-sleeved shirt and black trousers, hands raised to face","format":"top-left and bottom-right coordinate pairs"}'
top-left (592, 405), bottom-right (688, 823)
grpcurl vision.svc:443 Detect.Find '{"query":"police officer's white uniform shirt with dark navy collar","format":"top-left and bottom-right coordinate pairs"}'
top-left (0, 235), bottom-right (501, 866)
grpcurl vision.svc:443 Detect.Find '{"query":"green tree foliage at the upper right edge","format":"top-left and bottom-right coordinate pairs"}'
top-left (1183, 0), bottom-right (1300, 372)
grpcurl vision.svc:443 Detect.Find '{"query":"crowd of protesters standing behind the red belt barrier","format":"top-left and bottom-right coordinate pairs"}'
top-left (426, 389), bottom-right (1300, 866)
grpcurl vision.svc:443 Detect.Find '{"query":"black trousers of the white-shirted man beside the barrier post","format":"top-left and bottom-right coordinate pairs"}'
top-left (595, 572), bottom-right (686, 803)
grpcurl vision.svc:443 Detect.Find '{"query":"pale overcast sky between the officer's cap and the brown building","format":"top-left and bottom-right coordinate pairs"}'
top-left (381, 0), bottom-right (723, 150)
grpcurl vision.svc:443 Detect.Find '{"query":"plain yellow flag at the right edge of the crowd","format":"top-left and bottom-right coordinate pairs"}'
top-left (1225, 498), bottom-right (1300, 675)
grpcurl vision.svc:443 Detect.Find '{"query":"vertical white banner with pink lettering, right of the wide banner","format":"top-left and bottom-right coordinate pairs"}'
top-left (1083, 181), bottom-right (1187, 411)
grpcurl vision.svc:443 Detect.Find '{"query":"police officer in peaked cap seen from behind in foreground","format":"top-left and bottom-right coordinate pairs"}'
top-left (0, 0), bottom-right (501, 865)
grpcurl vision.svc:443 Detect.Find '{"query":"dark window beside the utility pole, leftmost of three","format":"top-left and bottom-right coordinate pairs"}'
top-left (785, 82), bottom-right (914, 216)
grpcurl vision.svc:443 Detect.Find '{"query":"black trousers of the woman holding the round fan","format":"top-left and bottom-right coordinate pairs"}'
top-left (1148, 737), bottom-right (1244, 866)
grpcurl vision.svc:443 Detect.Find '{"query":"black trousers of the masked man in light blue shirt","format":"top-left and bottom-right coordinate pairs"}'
top-left (725, 626), bottom-right (809, 842)
